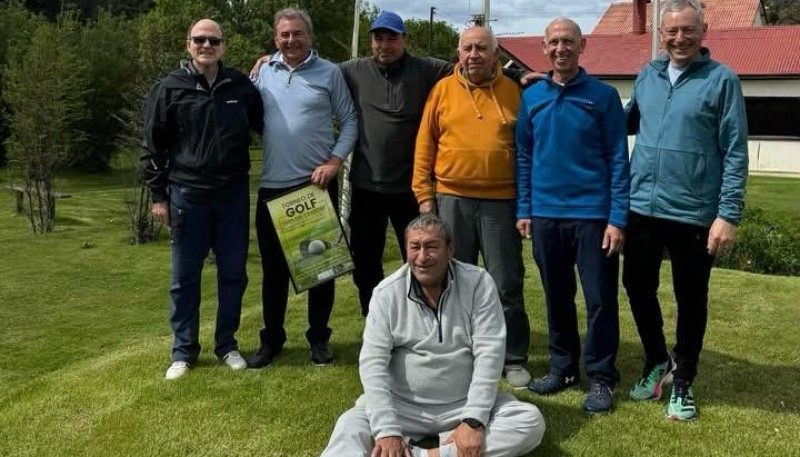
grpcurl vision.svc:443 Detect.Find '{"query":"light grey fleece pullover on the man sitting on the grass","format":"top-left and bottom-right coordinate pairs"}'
top-left (359, 260), bottom-right (506, 439)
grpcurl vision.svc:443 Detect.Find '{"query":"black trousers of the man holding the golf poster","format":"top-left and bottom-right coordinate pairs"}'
top-left (256, 179), bottom-right (339, 350)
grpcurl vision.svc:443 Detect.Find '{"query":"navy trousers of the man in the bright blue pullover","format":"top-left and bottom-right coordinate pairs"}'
top-left (532, 218), bottom-right (619, 388)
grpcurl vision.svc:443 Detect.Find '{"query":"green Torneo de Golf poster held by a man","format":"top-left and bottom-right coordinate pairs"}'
top-left (264, 184), bottom-right (354, 293)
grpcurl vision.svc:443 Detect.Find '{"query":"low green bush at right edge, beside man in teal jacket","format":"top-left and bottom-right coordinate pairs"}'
top-left (716, 207), bottom-right (800, 276)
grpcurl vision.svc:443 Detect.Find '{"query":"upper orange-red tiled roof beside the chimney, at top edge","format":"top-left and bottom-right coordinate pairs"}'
top-left (592, 0), bottom-right (760, 35)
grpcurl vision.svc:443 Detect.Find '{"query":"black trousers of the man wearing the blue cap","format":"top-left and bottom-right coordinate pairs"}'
top-left (348, 187), bottom-right (419, 316)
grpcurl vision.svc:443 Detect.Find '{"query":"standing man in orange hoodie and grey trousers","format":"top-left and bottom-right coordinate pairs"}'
top-left (412, 27), bottom-right (530, 387)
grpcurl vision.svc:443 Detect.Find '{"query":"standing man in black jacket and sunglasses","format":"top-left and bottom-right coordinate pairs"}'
top-left (141, 19), bottom-right (263, 379)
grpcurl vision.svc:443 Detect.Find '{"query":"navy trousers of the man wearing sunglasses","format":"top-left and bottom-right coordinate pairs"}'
top-left (169, 182), bottom-right (250, 363)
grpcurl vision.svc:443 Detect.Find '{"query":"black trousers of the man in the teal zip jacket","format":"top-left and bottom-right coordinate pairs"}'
top-left (622, 212), bottom-right (714, 382)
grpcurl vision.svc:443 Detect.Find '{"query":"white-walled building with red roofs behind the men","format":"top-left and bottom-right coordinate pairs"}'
top-left (498, 0), bottom-right (800, 173)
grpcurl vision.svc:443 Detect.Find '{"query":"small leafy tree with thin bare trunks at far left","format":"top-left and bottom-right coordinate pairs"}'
top-left (3, 15), bottom-right (88, 233)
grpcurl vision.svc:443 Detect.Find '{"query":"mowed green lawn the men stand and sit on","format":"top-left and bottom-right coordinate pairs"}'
top-left (0, 174), bottom-right (800, 457)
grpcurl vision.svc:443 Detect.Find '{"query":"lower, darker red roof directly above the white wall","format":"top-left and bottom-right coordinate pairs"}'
top-left (497, 25), bottom-right (800, 76)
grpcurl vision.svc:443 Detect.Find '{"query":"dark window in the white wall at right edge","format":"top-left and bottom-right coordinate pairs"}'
top-left (745, 97), bottom-right (800, 138)
